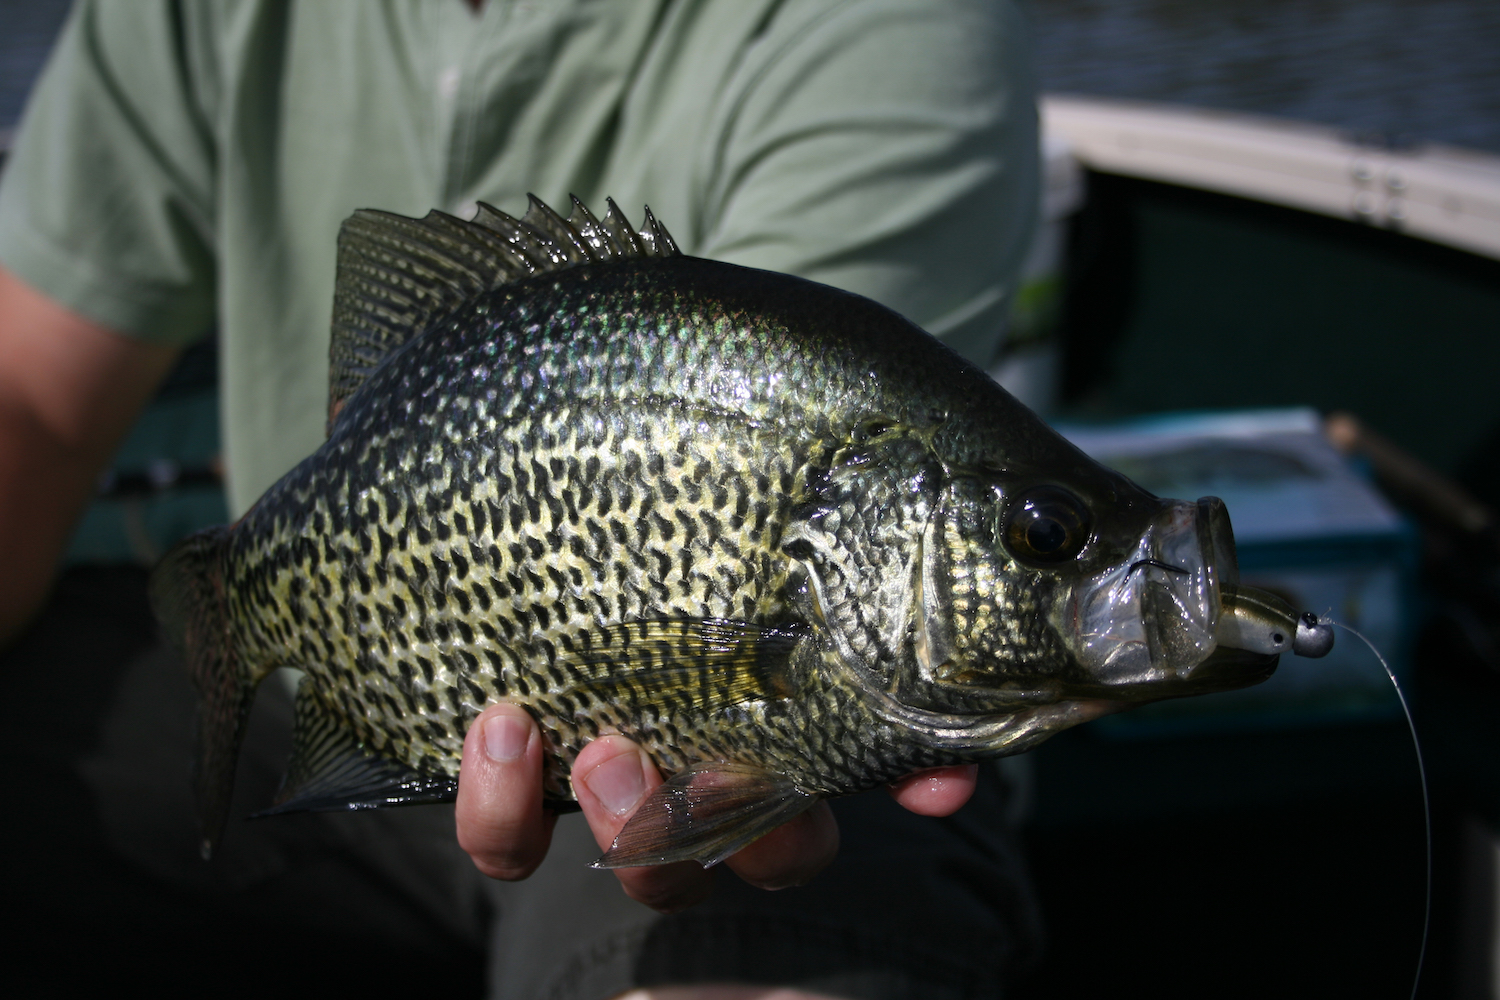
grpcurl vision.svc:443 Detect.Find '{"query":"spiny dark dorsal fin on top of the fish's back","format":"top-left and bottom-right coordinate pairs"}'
top-left (329, 195), bottom-right (681, 429)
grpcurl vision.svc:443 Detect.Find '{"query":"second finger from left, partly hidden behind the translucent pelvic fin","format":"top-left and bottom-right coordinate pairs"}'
top-left (573, 736), bottom-right (713, 913)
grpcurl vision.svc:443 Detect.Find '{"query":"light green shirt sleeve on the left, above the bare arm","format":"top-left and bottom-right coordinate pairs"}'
top-left (0, 0), bottom-right (215, 343)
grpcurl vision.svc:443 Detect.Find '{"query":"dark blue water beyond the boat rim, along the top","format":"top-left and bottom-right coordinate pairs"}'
top-left (0, 0), bottom-right (1500, 151)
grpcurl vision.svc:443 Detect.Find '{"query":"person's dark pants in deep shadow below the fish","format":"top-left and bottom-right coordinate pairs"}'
top-left (0, 570), bottom-right (1037, 999)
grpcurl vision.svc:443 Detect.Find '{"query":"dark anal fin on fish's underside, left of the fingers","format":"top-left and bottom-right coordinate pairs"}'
top-left (255, 678), bottom-right (459, 817)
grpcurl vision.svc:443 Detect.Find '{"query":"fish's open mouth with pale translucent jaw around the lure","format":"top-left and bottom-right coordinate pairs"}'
top-left (1067, 496), bottom-right (1295, 702)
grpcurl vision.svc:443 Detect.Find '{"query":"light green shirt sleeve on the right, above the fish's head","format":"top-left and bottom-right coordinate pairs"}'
top-left (701, 0), bottom-right (1040, 366)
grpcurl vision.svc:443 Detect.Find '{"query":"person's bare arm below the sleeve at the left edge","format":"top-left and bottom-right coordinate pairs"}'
top-left (0, 267), bottom-right (177, 643)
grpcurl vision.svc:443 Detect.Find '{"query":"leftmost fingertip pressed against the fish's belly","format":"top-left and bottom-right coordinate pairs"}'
top-left (453, 705), bottom-right (557, 882)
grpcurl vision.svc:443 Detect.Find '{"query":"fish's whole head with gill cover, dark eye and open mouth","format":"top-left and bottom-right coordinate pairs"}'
top-left (786, 410), bottom-right (1316, 742)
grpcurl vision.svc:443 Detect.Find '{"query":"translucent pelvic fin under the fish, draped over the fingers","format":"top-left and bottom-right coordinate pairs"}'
top-left (594, 762), bottom-right (819, 868)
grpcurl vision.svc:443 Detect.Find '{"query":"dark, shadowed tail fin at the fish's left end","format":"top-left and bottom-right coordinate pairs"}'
top-left (152, 528), bottom-right (257, 859)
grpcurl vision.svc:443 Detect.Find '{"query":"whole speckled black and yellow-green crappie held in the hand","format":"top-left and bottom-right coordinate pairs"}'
top-left (152, 196), bottom-right (1332, 867)
